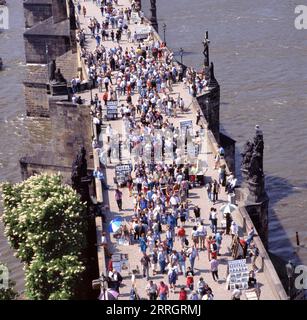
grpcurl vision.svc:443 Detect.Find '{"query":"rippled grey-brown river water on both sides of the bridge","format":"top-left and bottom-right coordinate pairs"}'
top-left (0, 0), bottom-right (307, 292)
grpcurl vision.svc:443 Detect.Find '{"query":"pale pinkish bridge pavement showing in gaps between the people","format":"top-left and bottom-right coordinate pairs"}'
top-left (80, 0), bottom-right (273, 300)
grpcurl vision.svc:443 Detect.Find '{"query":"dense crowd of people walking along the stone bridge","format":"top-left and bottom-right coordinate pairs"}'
top-left (77, 0), bottom-right (262, 300)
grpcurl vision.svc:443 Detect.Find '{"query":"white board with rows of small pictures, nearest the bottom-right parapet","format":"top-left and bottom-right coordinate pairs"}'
top-left (228, 259), bottom-right (249, 290)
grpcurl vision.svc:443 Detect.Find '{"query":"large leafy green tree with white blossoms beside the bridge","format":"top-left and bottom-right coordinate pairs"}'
top-left (2, 174), bottom-right (87, 299)
